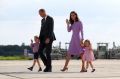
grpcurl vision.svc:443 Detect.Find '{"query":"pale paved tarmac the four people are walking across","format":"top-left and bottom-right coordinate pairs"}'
top-left (0, 60), bottom-right (120, 79)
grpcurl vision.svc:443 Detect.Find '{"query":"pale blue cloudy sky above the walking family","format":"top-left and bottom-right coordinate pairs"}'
top-left (0, 0), bottom-right (120, 48)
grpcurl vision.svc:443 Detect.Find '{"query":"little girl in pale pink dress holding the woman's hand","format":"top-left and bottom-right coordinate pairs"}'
top-left (83, 40), bottom-right (95, 72)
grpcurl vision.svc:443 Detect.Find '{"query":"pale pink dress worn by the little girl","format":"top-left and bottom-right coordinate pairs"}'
top-left (83, 47), bottom-right (95, 61)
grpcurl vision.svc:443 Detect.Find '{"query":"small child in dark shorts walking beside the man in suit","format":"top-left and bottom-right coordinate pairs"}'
top-left (28, 36), bottom-right (42, 72)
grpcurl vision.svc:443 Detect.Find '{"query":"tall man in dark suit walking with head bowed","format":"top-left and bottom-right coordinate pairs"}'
top-left (38, 9), bottom-right (56, 72)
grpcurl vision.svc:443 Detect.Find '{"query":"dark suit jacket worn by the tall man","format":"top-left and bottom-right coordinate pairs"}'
top-left (39, 16), bottom-right (56, 43)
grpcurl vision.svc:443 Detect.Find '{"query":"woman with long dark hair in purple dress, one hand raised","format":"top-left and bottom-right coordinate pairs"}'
top-left (61, 11), bottom-right (84, 71)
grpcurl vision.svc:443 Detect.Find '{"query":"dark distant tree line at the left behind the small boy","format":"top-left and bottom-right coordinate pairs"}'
top-left (0, 45), bottom-right (31, 56)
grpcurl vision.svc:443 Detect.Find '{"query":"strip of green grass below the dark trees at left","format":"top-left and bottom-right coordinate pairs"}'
top-left (0, 56), bottom-right (32, 60)
